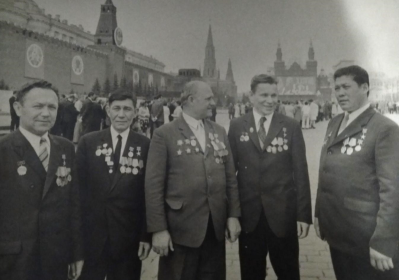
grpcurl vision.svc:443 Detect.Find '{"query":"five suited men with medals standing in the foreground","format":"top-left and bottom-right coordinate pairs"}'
top-left (0, 66), bottom-right (399, 280)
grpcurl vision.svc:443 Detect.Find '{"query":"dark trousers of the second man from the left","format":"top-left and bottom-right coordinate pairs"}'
top-left (79, 240), bottom-right (141, 280)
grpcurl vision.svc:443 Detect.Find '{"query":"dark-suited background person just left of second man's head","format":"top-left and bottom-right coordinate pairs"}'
top-left (80, 92), bottom-right (105, 136)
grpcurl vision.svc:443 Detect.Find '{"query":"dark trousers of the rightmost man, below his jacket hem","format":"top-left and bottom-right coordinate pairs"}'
top-left (330, 246), bottom-right (399, 280)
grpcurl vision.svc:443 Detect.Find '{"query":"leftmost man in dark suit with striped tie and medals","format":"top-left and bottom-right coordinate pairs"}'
top-left (0, 81), bottom-right (83, 280)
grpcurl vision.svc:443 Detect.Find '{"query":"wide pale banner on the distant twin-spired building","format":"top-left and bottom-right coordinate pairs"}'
top-left (278, 77), bottom-right (316, 95)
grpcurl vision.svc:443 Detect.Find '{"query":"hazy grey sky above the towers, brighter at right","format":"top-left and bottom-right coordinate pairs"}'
top-left (34, 0), bottom-right (399, 92)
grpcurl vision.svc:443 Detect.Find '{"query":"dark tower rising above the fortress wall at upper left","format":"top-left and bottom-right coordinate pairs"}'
top-left (95, 0), bottom-right (118, 45)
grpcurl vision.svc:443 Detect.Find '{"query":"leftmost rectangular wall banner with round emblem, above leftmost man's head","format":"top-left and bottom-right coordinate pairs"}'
top-left (25, 39), bottom-right (44, 79)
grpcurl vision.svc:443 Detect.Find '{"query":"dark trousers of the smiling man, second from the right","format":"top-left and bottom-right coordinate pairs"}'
top-left (239, 211), bottom-right (300, 280)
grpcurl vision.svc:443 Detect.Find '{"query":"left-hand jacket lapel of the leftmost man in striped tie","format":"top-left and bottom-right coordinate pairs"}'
top-left (13, 130), bottom-right (46, 180)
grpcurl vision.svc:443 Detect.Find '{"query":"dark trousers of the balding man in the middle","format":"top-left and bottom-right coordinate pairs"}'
top-left (158, 216), bottom-right (226, 280)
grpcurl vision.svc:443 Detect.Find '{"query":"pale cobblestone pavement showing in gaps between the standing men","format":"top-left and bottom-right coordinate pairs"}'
top-left (142, 111), bottom-right (336, 280)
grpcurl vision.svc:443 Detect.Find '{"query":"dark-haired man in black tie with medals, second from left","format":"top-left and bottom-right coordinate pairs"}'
top-left (76, 89), bottom-right (150, 280)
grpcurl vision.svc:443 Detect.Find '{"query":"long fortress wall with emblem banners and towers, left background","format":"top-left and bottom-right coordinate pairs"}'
top-left (0, 0), bottom-right (237, 104)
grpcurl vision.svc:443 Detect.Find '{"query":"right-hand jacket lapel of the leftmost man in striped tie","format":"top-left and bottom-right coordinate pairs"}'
top-left (42, 135), bottom-right (64, 199)
